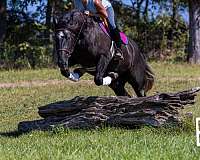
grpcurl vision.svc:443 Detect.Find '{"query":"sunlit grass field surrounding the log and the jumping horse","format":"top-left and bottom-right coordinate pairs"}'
top-left (0, 63), bottom-right (200, 160)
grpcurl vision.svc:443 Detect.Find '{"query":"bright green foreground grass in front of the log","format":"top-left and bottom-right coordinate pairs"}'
top-left (0, 128), bottom-right (200, 160)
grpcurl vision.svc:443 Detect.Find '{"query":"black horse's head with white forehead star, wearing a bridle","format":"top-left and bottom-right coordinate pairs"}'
top-left (54, 11), bottom-right (84, 77)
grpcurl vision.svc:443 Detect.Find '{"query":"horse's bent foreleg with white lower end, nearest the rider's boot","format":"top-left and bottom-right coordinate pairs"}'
top-left (94, 55), bottom-right (112, 86)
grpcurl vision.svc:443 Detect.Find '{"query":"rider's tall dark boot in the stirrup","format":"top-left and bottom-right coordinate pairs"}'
top-left (112, 28), bottom-right (124, 60)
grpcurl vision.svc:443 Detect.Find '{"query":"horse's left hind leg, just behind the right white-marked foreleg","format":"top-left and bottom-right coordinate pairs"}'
top-left (109, 78), bottom-right (131, 97)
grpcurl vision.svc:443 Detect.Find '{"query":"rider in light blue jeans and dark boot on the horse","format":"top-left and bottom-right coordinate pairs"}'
top-left (74, 0), bottom-right (124, 59)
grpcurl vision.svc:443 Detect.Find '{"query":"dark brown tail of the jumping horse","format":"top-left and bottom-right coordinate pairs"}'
top-left (144, 64), bottom-right (155, 92)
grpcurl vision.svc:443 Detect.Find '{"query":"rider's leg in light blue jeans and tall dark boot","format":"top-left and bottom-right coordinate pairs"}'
top-left (106, 7), bottom-right (123, 59)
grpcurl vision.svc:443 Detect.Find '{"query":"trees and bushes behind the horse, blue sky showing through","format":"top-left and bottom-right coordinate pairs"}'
top-left (0, 0), bottom-right (200, 68)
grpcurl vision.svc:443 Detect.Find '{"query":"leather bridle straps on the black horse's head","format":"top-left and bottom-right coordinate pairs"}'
top-left (56, 15), bottom-right (86, 57)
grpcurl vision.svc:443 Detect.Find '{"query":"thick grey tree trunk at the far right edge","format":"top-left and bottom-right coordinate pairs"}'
top-left (188, 0), bottom-right (200, 64)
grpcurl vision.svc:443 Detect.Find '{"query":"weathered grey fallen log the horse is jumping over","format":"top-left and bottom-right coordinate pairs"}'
top-left (18, 87), bottom-right (200, 132)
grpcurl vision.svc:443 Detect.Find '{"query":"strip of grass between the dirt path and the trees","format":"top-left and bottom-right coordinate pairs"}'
top-left (0, 62), bottom-right (200, 82)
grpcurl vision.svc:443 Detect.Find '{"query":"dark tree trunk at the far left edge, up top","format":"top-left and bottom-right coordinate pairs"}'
top-left (0, 0), bottom-right (6, 44)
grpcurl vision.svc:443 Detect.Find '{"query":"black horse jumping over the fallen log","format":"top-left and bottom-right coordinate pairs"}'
top-left (54, 10), bottom-right (154, 96)
